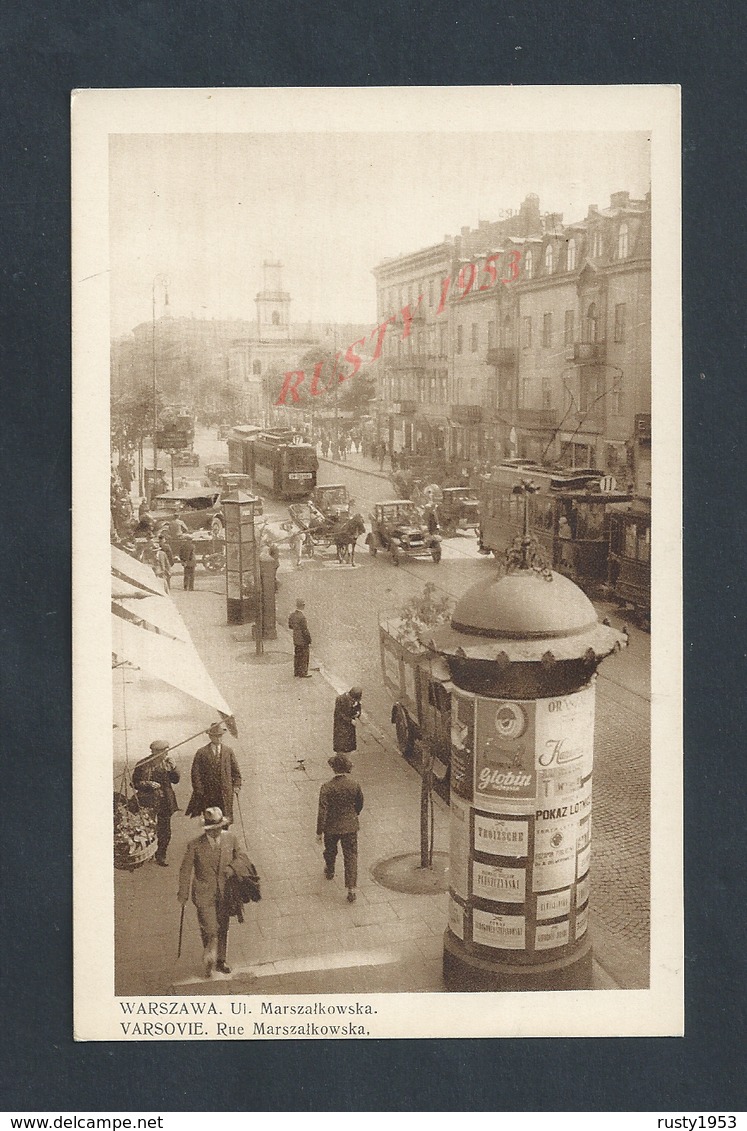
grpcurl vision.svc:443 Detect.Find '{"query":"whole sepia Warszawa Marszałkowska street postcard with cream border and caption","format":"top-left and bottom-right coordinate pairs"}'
top-left (72, 86), bottom-right (684, 1042)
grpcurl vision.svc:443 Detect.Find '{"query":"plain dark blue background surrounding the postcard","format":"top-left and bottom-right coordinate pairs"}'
top-left (0, 0), bottom-right (746, 1112)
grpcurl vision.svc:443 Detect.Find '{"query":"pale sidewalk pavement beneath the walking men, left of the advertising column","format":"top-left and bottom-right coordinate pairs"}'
top-left (114, 549), bottom-right (617, 995)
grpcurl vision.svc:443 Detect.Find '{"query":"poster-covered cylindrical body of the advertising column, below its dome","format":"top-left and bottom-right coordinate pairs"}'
top-left (447, 679), bottom-right (594, 988)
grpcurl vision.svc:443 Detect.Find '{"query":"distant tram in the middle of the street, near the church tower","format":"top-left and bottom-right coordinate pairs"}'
top-left (222, 425), bottom-right (319, 499)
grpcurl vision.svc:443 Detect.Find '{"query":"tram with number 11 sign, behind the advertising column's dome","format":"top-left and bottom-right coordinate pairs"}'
top-left (478, 460), bottom-right (632, 592)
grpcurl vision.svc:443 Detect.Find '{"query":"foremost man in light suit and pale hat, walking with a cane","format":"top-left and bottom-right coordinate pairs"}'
top-left (177, 806), bottom-right (249, 978)
